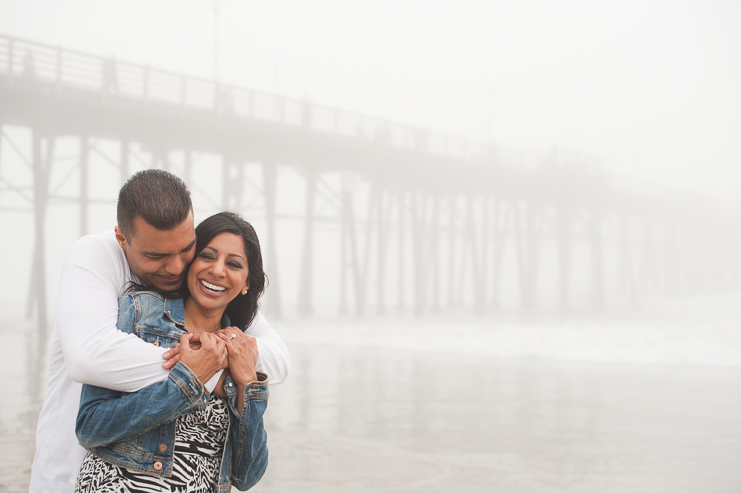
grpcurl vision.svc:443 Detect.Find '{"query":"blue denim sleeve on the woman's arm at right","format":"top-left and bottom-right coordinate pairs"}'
top-left (224, 372), bottom-right (268, 491)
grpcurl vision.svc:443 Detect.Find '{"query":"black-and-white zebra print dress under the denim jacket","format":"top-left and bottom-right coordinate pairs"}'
top-left (75, 394), bottom-right (229, 493)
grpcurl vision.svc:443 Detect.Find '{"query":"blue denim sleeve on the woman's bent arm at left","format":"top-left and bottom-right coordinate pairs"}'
top-left (75, 296), bottom-right (208, 448)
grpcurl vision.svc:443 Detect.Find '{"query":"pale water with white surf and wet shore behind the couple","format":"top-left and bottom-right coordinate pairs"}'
top-left (0, 293), bottom-right (741, 493)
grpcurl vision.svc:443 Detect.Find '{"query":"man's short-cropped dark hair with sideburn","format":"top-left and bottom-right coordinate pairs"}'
top-left (116, 169), bottom-right (193, 240)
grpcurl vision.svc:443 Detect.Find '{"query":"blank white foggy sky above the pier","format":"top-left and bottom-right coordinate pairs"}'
top-left (0, 0), bottom-right (741, 197)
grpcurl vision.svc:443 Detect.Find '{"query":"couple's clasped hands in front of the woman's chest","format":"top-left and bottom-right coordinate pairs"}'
top-left (162, 327), bottom-right (258, 397)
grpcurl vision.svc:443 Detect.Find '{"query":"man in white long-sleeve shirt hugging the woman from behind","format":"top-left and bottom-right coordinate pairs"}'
top-left (29, 170), bottom-right (290, 493)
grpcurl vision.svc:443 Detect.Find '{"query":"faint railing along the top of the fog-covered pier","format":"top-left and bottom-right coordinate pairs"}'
top-left (0, 35), bottom-right (506, 163)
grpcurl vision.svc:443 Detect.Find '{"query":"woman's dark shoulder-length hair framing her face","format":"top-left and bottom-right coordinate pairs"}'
top-left (188, 212), bottom-right (267, 331)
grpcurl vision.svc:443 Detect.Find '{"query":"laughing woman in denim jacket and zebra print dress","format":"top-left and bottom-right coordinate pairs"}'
top-left (76, 212), bottom-right (268, 493)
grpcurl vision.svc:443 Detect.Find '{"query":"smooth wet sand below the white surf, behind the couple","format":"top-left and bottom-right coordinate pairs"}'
top-left (0, 323), bottom-right (741, 493)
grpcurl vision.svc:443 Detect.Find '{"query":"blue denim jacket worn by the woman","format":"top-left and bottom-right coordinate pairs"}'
top-left (75, 291), bottom-right (268, 492)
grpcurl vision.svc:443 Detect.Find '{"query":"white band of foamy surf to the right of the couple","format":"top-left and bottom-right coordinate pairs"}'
top-left (278, 293), bottom-right (741, 367)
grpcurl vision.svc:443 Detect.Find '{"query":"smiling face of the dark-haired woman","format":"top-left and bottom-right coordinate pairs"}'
top-left (186, 233), bottom-right (250, 310)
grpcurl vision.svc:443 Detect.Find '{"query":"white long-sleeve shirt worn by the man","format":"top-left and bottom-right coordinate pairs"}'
top-left (29, 231), bottom-right (291, 493)
